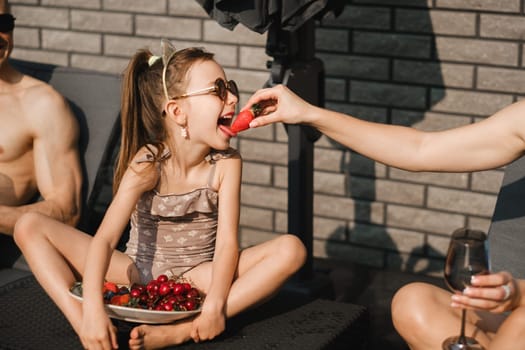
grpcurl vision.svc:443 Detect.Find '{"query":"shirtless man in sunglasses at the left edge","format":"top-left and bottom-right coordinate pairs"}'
top-left (0, 0), bottom-right (82, 266)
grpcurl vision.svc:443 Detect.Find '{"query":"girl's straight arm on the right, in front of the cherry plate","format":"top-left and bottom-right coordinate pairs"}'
top-left (192, 155), bottom-right (242, 341)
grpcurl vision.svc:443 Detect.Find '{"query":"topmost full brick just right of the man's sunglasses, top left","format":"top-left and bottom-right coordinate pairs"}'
top-left (12, 6), bottom-right (70, 29)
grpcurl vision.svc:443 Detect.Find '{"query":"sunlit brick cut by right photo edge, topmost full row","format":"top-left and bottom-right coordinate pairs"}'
top-left (480, 14), bottom-right (525, 40)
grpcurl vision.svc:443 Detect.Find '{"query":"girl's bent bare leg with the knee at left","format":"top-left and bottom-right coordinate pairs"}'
top-left (14, 213), bottom-right (134, 334)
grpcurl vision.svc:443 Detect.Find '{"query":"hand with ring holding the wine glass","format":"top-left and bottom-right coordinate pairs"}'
top-left (451, 271), bottom-right (521, 313)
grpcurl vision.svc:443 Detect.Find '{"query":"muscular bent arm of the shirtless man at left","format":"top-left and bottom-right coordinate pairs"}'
top-left (0, 84), bottom-right (82, 234)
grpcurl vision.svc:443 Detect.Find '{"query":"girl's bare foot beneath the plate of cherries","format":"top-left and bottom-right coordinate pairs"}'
top-left (129, 320), bottom-right (191, 350)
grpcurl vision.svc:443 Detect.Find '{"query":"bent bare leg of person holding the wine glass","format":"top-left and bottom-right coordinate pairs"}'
top-left (392, 282), bottom-right (497, 350)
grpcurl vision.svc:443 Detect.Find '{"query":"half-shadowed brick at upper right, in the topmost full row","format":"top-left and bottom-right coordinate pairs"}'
top-left (396, 9), bottom-right (476, 36)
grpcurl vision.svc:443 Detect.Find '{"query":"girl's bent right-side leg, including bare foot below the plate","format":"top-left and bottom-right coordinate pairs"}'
top-left (129, 234), bottom-right (306, 350)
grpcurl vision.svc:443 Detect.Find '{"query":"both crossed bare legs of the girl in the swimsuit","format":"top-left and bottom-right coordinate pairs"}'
top-left (14, 213), bottom-right (306, 350)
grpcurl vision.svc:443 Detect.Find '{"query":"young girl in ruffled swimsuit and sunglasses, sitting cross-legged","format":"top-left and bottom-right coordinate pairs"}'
top-left (15, 41), bottom-right (305, 349)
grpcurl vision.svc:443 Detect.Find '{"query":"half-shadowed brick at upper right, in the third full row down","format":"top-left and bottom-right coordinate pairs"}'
top-left (393, 60), bottom-right (474, 88)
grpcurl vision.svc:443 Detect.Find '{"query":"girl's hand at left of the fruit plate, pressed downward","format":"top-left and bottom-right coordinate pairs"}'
top-left (80, 309), bottom-right (118, 350)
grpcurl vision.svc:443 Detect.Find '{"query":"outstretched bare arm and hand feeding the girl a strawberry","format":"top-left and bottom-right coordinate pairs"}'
top-left (248, 85), bottom-right (525, 172)
